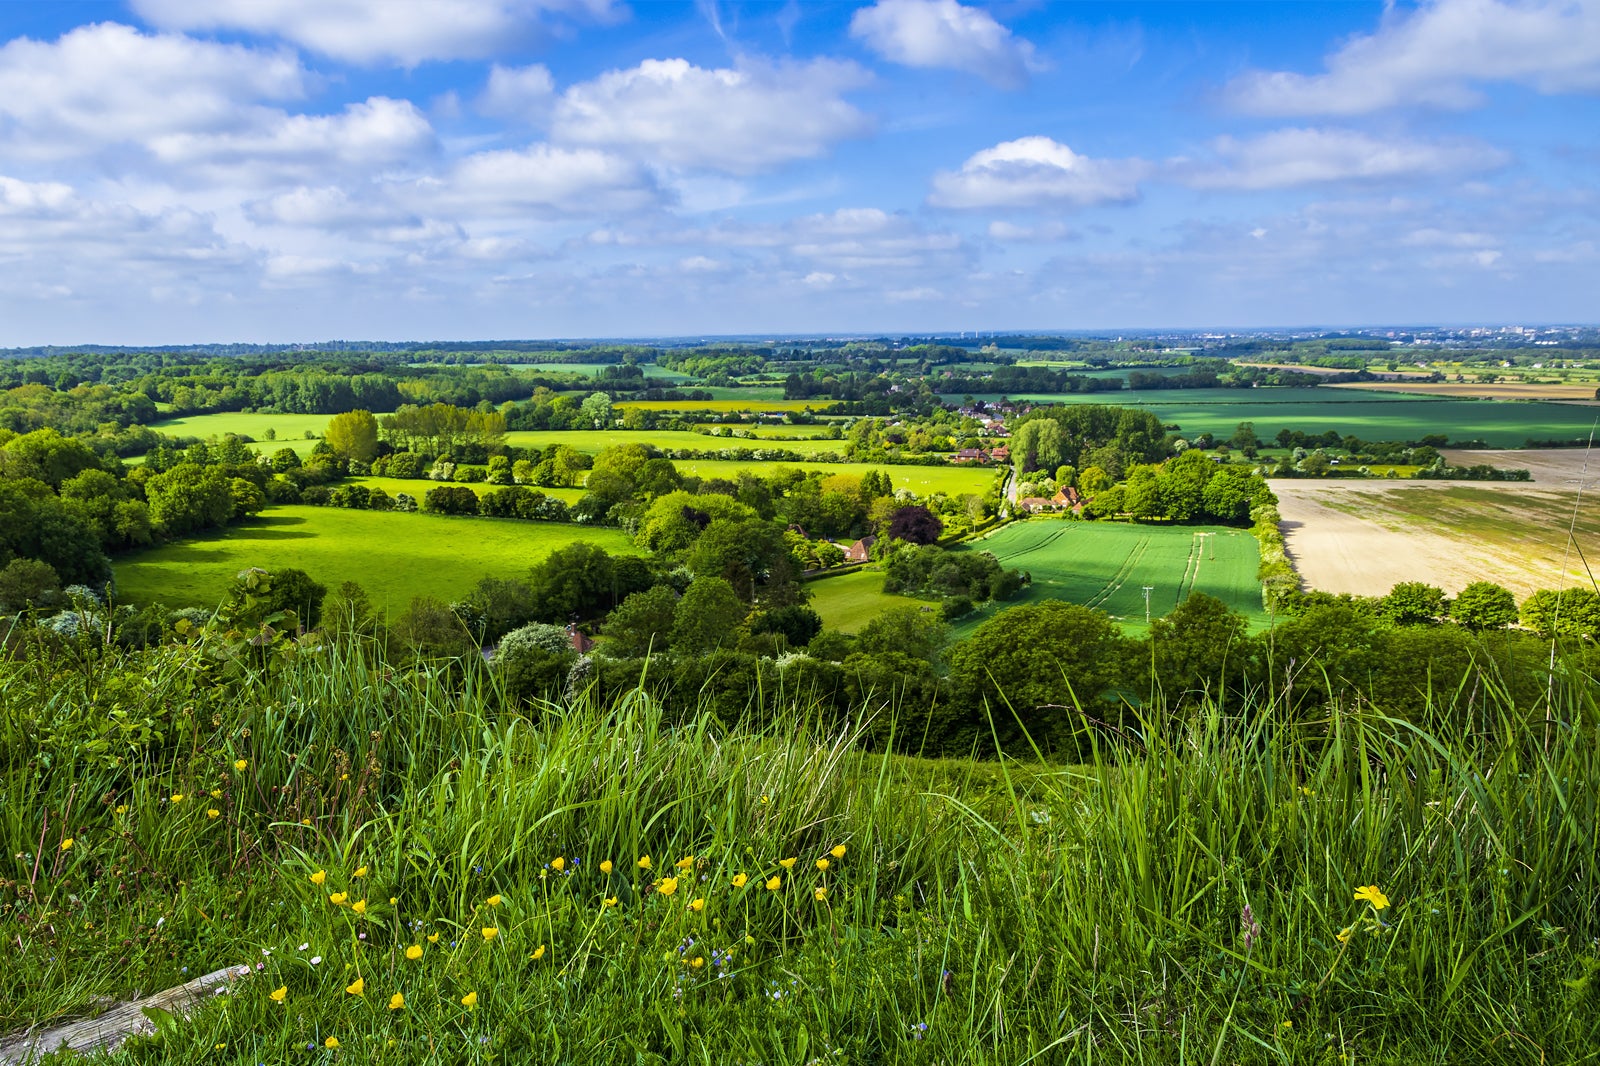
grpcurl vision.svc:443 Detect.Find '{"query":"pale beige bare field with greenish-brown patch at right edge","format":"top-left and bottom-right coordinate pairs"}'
top-left (1272, 473), bottom-right (1600, 599)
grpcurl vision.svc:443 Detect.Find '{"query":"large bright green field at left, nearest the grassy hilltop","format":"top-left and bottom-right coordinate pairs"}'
top-left (117, 507), bottom-right (634, 611)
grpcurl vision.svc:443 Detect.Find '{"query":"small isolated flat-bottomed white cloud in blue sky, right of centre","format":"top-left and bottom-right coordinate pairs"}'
top-left (928, 136), bottom-right (1149, 208)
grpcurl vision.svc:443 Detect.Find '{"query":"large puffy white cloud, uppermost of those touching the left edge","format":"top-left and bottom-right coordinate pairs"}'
top-left (0, 22), bottom-right (307, 158)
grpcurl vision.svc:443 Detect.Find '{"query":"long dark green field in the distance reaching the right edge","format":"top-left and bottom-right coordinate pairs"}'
top-left (944, 387), bottom-right (1595, 448)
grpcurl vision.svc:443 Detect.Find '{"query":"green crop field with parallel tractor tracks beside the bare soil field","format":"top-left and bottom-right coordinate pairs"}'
top-left (957, 519), bottom-right (1266, 634)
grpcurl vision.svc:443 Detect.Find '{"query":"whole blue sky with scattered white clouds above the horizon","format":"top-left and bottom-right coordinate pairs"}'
top-left (0, 0), bottom-right (1600, 346)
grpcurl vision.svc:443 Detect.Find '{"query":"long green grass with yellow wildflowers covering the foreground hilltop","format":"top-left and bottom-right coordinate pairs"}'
top-left (0, 633), bottom-right (1600, 1063)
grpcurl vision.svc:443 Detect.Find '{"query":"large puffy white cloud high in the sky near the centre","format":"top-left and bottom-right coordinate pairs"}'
top-left (552, 59), bottom-right (870, 174)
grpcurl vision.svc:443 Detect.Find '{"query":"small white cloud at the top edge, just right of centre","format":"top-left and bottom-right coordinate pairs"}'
top-left (850, 0), bottom-right (1038, 88)
